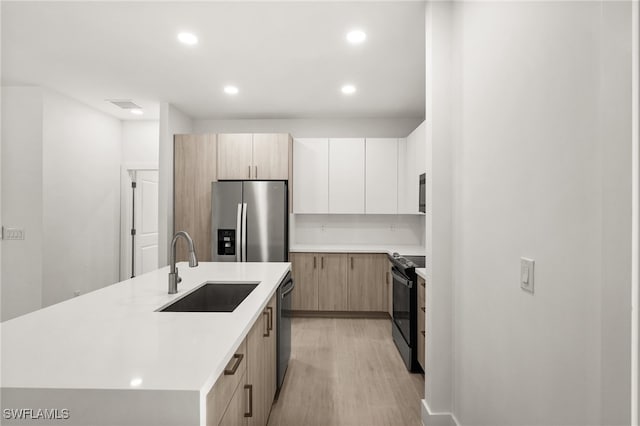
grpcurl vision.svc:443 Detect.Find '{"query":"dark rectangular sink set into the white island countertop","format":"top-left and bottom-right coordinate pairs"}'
top-left (159, 282), bottom-right (259, 312)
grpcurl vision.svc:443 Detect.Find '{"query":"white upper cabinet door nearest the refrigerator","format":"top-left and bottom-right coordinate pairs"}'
top-left (293, 138), bottom-right (329, 214)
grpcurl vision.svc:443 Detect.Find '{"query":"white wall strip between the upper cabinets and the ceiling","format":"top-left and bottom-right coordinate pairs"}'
top-left (193, 118), bottom-right (423, 138)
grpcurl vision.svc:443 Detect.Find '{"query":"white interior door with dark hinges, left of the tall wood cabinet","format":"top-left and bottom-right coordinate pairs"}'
top-left (133, 170), bottom-right (158, 276)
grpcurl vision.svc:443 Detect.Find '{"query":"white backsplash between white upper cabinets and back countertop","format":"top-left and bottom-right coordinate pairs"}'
top-left (291, 214), bottom-right (424, 248)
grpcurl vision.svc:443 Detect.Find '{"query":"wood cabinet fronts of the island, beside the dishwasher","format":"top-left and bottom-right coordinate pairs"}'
top-left (207, 296), bottom-right (277, 426)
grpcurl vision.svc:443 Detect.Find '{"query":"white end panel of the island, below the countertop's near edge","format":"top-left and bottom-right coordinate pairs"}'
top-left (0, 388), bottom-right (200, 426)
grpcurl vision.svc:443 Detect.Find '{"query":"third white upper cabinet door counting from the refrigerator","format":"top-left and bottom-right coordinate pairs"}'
top-left (365, 138), bottom-right (398, 214)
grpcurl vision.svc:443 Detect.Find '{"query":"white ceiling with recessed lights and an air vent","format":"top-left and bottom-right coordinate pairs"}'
top-left (1, 1), bottom-right (425, 119)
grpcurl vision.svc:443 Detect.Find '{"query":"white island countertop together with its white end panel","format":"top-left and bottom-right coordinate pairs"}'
top-left (0, 263), bottom-right (290, 426)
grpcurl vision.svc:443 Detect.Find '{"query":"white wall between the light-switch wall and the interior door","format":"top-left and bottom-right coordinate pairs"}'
top-left (42, 91), bottom-right (122, 306)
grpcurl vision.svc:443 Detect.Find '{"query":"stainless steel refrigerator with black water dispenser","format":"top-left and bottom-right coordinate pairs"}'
top-left (211, 181), bottom-right (289, 262)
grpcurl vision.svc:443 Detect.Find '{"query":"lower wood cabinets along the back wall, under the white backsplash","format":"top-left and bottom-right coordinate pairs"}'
top-left (290, 253), bottom-right (391, 312)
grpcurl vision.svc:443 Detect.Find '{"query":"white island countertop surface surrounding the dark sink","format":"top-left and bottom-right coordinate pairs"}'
top-left (0, 262), bottom-right (290, 395)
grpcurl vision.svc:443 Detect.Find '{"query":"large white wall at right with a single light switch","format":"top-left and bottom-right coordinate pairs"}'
top-left (427, 2), bottom-right (631, 425)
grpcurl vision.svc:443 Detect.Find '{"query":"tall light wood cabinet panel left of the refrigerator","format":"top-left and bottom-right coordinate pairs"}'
top-left (173, 135), bottom-right (216, 262)
